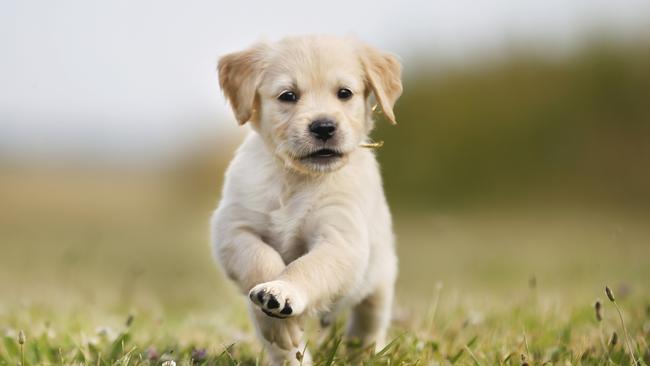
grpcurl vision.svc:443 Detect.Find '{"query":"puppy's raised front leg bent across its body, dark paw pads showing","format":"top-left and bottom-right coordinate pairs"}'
top-left (249, 206), bottom-right (369, 318)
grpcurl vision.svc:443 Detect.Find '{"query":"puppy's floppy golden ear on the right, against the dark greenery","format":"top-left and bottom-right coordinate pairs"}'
top-left (361, 46), bottom-right (402, 124)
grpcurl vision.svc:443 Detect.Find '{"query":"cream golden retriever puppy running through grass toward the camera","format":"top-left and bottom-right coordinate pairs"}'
top-left (211, 36), bottom-right (402, 364)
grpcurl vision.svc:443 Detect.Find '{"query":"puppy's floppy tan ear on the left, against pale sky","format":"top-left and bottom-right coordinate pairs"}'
top-left (217, 43), bottom-right (267, 125)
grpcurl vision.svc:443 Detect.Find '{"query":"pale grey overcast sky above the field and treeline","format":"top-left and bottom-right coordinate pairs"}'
top-left (0, 0), bottom-right (650, 161)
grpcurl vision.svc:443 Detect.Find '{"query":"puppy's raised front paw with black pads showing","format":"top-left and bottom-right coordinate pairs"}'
top-left (248, 281), bottom-right (305, 319)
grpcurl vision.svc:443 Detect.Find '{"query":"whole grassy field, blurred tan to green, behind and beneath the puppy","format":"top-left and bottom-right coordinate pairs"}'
top-left (0, 171), bottom-right (650, 365)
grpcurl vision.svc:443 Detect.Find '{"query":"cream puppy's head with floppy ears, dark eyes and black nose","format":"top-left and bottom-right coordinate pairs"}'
top-left (218, 36), bottom-right (402, 174)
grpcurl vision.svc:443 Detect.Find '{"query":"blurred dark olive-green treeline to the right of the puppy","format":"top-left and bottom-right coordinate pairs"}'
top-left (374, 40), bottom-right (650, 210)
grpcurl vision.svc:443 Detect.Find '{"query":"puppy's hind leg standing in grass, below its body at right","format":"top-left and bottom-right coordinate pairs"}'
top-left (347, 281), bottom-right (394, 352)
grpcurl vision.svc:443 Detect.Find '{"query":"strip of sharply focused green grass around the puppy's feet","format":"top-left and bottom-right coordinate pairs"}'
top-left (0, 289), bottom-right (650, 365)
